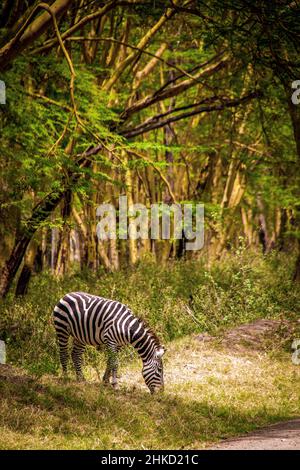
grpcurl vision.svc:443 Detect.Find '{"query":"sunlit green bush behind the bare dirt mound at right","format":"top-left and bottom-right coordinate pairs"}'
top-left (192, 247), bottom-right (300, 333)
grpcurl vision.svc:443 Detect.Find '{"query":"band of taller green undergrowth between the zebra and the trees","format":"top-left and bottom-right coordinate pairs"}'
top-left (0, 249), bottom-right (300, 375)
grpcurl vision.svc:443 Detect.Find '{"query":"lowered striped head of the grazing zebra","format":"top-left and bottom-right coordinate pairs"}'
top-left (143, 346), bottom-right (165, 394)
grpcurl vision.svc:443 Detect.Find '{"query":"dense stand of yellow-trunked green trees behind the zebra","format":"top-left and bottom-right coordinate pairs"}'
top-left (0, 0), bottom-right (299, 296)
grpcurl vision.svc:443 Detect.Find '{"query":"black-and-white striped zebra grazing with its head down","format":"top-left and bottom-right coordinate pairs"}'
top-left (53, 292), bottom-right (165, 394)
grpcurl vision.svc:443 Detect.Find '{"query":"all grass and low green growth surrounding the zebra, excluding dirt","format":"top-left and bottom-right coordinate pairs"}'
top-left (0, 249), bottom-right (300, 449)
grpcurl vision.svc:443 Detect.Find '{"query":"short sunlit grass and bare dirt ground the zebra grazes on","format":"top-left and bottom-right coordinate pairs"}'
top-left (0, 320), bottom-right (300, 449)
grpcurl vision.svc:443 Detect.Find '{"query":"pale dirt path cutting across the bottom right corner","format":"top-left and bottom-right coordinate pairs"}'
top-left (211, 419), bottom-right (300, 450)
